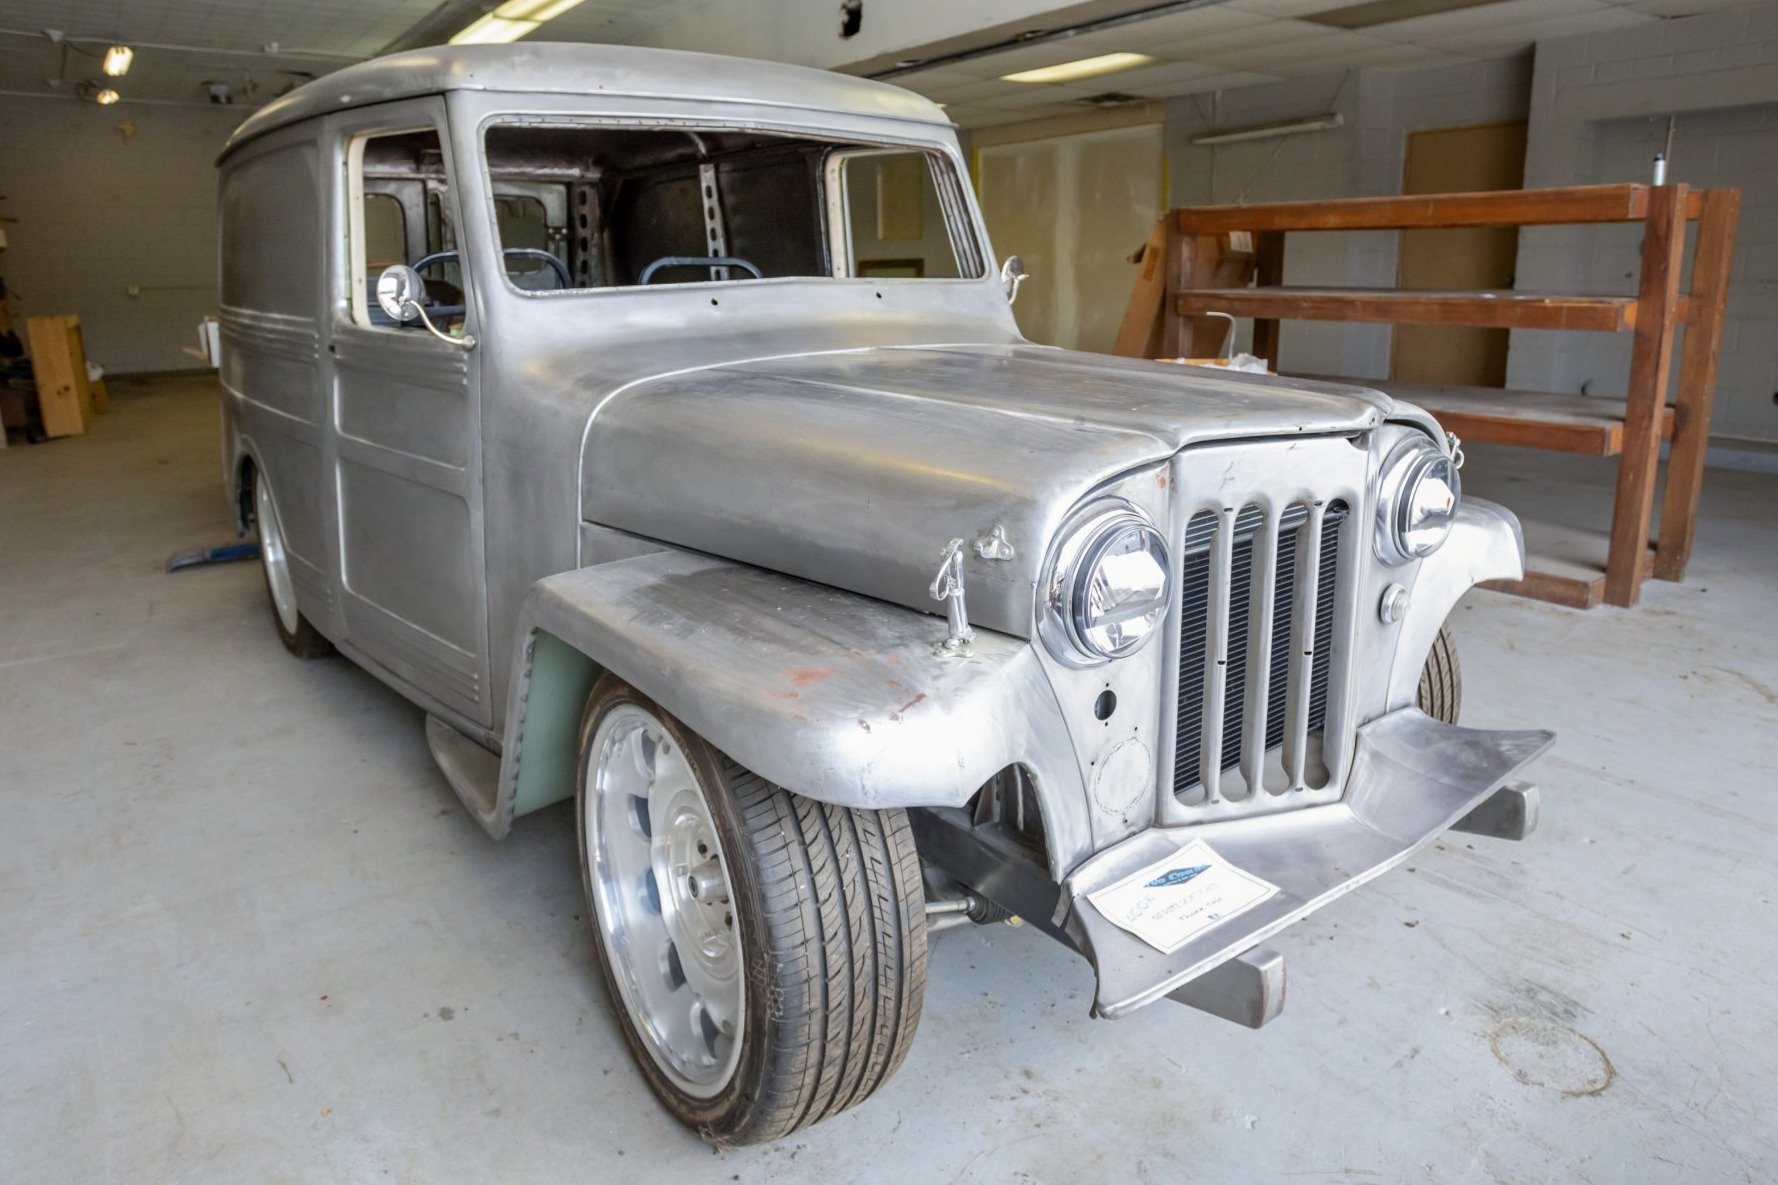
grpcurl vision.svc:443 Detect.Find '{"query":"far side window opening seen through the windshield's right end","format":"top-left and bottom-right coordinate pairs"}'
top-left (829, 151), bottom-right (964, 279)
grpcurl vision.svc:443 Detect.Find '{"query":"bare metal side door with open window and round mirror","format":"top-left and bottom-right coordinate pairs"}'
top-left (327, 100), bottom-right (494, 726)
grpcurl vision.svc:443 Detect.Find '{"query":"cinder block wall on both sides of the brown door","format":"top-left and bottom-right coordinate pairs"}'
top-left (1166, 4), bottom-right (1778, 445)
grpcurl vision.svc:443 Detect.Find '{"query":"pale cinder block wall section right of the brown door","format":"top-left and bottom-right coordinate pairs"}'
top-left (1508, 5), bottom-right (1778, 445)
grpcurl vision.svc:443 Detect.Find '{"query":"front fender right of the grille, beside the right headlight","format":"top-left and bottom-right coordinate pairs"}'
top-left (1389, 498), bottom-right (1526, 712)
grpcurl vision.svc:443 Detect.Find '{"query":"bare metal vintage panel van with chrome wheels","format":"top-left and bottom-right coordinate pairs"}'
top-left (220, 44), bottom-right (1550, 1144)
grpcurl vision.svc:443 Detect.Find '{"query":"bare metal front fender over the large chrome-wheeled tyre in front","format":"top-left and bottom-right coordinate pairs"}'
top-left (485, 550), bottom-right (1077, 834)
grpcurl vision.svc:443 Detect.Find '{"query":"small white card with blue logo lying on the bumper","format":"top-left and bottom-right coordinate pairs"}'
top-left (1086, 840), bottom-right (1278, 954)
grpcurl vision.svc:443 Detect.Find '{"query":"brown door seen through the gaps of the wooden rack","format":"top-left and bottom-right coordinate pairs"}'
top-left (1390, 123), bottom-right (1526, 386)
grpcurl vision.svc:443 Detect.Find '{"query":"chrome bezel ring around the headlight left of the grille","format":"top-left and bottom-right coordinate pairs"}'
top-left (1038, 500), bottom-right (1173, 667)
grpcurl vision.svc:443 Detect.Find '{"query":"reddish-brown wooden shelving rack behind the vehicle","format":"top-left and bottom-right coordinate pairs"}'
top-left (1118, 185), bottom-right (1741, 609)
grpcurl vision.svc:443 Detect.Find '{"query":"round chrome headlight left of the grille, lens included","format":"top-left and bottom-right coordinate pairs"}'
top-left (1038, 502), bottom-right (1170, 665)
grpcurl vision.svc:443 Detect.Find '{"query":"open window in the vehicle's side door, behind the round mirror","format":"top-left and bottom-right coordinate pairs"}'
top-left (347, 128), bottom-right (464, 333)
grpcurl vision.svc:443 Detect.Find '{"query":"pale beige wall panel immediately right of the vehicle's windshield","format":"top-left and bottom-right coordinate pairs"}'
top-left (976, 123), bottom-right (1165, 354)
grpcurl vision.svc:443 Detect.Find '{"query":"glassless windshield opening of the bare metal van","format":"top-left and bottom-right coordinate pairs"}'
top-left (484, 123), bottom-right (983, 292)
